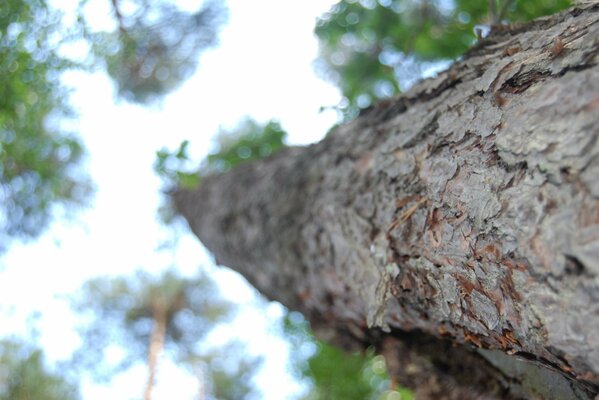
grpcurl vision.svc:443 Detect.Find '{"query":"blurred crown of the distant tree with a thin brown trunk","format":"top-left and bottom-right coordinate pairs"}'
top-left (73, 270), bottom-right (231, 380)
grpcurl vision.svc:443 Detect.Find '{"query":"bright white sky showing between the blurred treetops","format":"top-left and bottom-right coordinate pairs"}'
top-left (0, 0), bottom-right (339, 400)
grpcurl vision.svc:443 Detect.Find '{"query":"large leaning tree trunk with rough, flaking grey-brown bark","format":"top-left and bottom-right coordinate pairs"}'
top-left (173, 5), bottom-right (599, 399)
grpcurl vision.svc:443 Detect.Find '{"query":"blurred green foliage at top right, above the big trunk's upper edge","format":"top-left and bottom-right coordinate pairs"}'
top-left (315, 0), bottom-right (570, 116)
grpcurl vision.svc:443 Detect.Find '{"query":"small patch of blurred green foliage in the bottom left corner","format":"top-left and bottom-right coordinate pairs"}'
top-left (0, 339), bottom-right (79, 400)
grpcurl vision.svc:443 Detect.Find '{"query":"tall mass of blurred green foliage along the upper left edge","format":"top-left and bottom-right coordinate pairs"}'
top-left (0, 0), bottom-right (89, 247)
